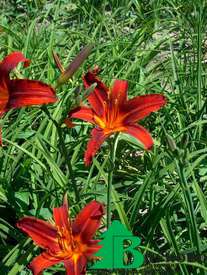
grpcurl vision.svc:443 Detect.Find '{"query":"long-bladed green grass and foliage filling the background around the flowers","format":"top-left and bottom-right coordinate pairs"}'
top-left (0, 0), bottom-right (207, 275)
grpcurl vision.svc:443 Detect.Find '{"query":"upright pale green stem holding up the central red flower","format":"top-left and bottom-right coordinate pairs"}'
top-left (107, 134), bottom-right (118, 228)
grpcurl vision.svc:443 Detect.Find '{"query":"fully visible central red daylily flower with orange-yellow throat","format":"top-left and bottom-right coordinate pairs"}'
top-left (65, 67), bottom-right (166, 165)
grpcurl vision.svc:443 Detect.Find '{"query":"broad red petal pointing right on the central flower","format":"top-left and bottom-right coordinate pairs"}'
top-left (123, 94), bottom-right (166, 123)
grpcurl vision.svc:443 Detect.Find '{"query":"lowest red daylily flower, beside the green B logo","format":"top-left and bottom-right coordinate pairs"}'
top-left (17, 197), bottom-right (104, 275)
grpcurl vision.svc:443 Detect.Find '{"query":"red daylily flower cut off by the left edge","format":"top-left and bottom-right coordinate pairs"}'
top-left (0, 52), bottom-right (57, 145)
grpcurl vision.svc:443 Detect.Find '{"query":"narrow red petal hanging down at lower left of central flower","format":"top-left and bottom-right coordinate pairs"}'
top-left (84, 128), bottom-right (107, 165)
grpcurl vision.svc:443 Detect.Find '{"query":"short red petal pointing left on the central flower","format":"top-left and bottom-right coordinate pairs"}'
top-left (68, 106), bottom-right (94, 123)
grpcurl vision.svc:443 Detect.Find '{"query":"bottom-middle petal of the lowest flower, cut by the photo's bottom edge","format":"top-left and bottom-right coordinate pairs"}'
top-left (64, 256), bottom-right (87, 275)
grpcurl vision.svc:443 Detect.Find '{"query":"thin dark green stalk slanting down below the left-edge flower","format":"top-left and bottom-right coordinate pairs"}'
top-left (42, 106), bottom-right (80, 202)
